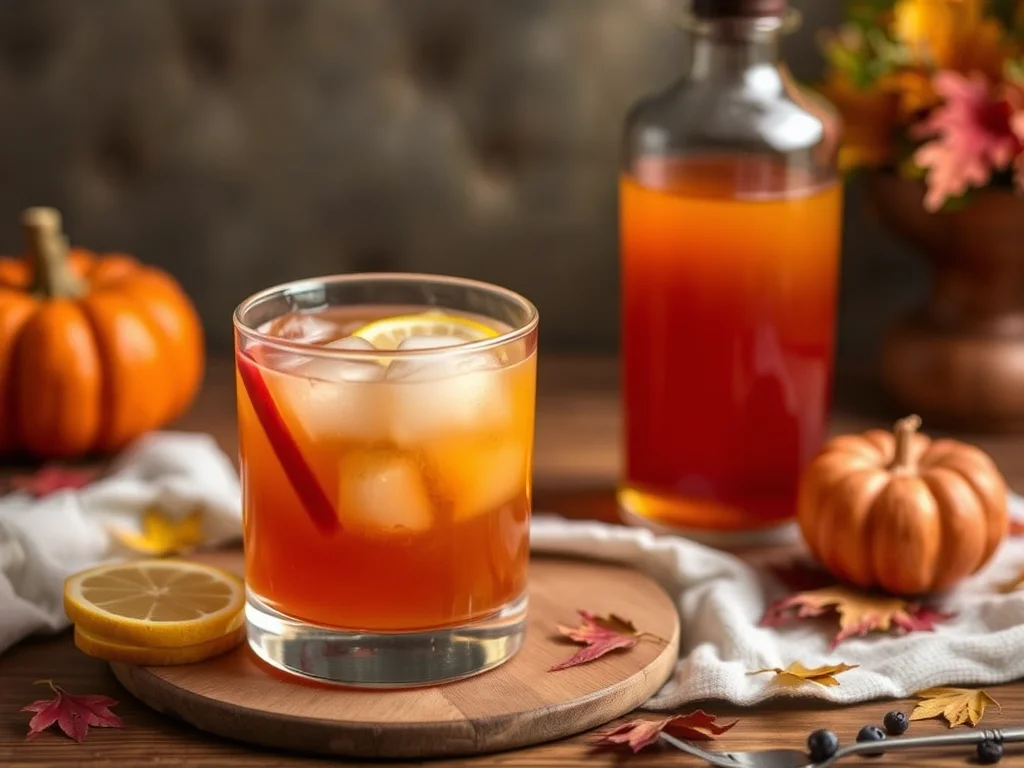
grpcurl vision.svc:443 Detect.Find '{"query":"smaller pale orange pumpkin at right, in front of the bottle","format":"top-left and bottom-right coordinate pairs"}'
top-left (798, 416), bottom-right (1009, 595)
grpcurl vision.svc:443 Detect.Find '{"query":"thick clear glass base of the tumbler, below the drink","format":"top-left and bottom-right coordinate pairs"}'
top-left (246, 592), bottom-right (527, 688)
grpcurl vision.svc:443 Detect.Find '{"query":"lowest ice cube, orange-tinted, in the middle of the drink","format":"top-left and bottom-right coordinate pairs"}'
top-left (338, 451), bottom-right (434, 532)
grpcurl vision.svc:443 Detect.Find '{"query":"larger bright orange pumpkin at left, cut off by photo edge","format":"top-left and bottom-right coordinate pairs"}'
top-left (0, 208), bottom-right (204, 458)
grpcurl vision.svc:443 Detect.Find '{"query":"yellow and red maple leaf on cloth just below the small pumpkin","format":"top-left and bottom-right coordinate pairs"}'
top-left (761, 587), bottom-right (954, 650)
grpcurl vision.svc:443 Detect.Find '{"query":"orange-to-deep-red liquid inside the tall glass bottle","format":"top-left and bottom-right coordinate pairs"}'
top-left (620, 160), bottom-right (842, 531)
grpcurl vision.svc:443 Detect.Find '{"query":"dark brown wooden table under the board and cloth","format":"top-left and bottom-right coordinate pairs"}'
top-left (0, 357), bottom-right (1024, 768)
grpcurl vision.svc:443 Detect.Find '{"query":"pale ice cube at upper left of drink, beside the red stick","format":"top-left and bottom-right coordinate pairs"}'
top-left (270, 337), bottom-right (388, 441)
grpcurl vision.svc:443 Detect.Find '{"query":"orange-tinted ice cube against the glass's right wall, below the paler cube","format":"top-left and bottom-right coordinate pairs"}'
top-left (428, 436), bottom-right (529, 520)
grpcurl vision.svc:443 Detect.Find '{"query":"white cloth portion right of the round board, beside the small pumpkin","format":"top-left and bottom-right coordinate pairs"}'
top-left (530, 497), bottom-right (1024, 710)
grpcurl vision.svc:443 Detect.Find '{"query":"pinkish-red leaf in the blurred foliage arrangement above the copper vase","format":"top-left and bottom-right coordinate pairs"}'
top-left (913, 71), bottom-right (1021, 212)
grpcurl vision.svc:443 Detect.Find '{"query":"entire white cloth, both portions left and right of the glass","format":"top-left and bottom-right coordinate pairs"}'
top-left (6, 432), bottom-right (1024, 710)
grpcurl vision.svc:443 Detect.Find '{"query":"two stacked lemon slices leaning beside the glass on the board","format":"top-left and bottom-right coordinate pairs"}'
top-left (63, 560), bottom-right (246, 648)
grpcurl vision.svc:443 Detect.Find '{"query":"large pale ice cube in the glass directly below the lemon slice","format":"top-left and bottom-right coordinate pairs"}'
top-left (387, 352), bottom-right (512, 444)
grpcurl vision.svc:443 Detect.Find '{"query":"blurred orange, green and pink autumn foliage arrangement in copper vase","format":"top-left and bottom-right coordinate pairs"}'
top-left (822, 0), bottom-right (1024, 212)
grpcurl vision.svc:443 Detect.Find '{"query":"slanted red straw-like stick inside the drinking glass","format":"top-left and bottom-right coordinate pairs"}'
top-left (236, 351), bottom-right (340, 534)
